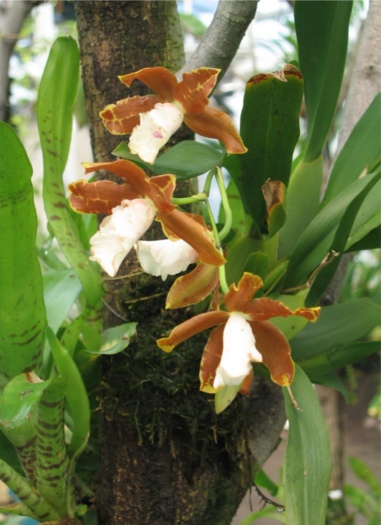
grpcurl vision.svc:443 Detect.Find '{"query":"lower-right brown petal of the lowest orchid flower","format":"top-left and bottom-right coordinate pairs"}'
top-left (249, 321), bottom-right (295, 386)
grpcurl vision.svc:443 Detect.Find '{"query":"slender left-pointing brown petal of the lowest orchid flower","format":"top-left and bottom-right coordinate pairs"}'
top-left (157, 311), bottom-right (229, 352)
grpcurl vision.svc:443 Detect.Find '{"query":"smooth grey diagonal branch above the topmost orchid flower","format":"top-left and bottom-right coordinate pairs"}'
top-left (179, 0), bottom-right (259, 79)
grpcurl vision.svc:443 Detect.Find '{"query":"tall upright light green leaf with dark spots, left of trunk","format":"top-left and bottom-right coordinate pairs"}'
top-left (37, 37), bottom-right (102, 305)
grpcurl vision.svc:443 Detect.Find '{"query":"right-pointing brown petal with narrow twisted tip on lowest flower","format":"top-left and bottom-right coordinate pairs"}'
top-left (241, 297), bottom-right (321, 322)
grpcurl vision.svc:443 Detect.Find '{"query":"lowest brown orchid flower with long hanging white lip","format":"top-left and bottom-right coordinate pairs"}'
top-left (157, 273), bottom-right (320, 393)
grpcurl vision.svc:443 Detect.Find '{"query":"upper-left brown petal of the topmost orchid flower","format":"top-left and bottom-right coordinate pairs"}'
top-left (119, 67), bottom-right (177, 102)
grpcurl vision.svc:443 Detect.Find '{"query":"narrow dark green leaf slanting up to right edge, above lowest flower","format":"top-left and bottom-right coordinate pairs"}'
top-left (305, 170), bottom-right (377, 306)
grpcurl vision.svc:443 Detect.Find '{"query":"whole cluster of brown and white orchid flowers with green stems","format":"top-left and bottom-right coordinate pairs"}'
top-left (69, 67), bottom-right (320, 409)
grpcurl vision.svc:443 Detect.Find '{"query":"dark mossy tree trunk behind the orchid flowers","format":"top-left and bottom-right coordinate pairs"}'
top-left (75, 0), bottom-right (284, 525)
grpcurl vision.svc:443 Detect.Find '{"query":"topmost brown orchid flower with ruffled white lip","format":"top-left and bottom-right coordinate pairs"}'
top-left (100, 67), bottom-right (247, 164)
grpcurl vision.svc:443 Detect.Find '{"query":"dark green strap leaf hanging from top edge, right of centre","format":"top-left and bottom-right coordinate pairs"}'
top-left (294, 0), bottom-right (353, 162)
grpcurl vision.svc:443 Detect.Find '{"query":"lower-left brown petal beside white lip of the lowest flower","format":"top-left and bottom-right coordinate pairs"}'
top-left (199, 325), bottom-right (225, 394)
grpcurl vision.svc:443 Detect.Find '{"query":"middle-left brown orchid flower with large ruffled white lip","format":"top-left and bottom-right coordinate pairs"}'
top-left (69, 159), bottom-right (225, 277)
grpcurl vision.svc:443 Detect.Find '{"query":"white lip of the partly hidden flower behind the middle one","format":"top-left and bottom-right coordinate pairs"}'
top-left (135, 239), bottom-right (198, 281)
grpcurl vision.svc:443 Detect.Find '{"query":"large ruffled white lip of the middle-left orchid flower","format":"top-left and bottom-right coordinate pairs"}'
top-left (90, 199), bottom-right (156, 277)
